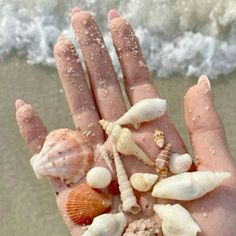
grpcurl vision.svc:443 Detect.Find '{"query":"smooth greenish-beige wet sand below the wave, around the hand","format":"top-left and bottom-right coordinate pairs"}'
top-left (0, 57), bottom-right (236, 236)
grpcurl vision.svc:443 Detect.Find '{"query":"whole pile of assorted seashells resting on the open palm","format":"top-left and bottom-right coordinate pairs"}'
top-left (30, 98), bottom-right (230, 236)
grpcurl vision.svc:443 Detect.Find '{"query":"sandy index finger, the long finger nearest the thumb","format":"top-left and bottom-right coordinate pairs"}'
top-left (108, 10), bottom-right (158, 104)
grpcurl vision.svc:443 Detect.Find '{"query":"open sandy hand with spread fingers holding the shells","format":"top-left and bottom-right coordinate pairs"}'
top-left (16, 8), bottom-right (236, 236)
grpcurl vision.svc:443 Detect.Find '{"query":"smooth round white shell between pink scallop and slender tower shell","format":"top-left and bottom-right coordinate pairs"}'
top-left (86, 166), bottom-right (111, 189)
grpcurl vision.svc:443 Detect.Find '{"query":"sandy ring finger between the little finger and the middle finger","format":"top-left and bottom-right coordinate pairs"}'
top-left (54, 36), bottom-right (104, 144)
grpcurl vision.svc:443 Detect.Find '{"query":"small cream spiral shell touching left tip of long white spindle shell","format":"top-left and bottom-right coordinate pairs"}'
top-left (129, 173), bottom-right (158, 192)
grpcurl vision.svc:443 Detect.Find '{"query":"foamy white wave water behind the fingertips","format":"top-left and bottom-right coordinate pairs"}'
top-left (0, 0), bottom-right (236, 78)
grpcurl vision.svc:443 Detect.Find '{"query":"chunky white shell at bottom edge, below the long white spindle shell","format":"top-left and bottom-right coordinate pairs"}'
top-left (153, 204), bottom-right (201, 236)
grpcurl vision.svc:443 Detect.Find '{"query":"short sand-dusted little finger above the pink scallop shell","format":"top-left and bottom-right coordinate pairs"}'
top-left (15, 100), bottom-right (47, 153)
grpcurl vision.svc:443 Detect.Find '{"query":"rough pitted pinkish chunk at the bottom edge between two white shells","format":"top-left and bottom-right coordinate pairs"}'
top-left (123, 219), bottom-right (159, 236)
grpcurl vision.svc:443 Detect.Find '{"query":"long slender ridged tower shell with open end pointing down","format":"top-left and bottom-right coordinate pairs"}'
top-left (113, 146), bottom-right (141, 214)
